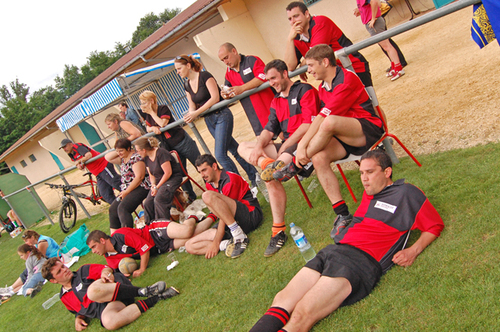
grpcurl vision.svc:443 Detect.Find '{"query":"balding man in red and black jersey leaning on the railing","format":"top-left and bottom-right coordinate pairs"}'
top-left (219, 43), bottom-right (274, 136)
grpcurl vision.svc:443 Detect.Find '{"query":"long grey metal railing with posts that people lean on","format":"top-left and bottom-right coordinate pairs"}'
top-left (3, 0), bottom-right (481, 225)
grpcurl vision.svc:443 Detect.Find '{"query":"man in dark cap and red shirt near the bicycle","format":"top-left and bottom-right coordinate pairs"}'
top-left (59, 138), bottom-right (121, 204)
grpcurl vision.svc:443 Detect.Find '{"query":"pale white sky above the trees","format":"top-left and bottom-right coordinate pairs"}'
top-left (0, 0), bottom-right (195, 92)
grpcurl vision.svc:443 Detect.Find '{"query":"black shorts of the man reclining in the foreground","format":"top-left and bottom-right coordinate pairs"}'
top-left (305, 244), bottom-right (382, 306)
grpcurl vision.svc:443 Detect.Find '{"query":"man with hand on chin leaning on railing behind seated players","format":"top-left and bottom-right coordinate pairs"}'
top-left (285, 1), bottom-right (373, 87)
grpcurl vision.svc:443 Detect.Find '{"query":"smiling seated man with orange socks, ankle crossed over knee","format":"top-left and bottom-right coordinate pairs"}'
top-left (238, 60), bottom-right (319, 257)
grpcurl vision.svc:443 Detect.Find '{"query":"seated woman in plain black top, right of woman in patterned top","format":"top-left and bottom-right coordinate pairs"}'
top-left (134, 137), bottom-right (183, 225)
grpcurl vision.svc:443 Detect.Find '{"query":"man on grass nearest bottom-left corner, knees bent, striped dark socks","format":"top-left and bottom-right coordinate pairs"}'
top-left (42, 257), bottom-right (179, 331)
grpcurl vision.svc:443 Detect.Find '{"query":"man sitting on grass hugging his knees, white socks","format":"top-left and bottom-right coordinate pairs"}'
top-left (186, 154), bottom-right (263, 258)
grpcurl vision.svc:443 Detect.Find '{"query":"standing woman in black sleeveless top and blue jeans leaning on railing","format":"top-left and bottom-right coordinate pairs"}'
top-left (174, 54), bottom-right (257, 186)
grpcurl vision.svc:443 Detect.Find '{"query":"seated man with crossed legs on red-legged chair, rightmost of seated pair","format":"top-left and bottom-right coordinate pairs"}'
top-left (273, 44), bottom-right (384, 237)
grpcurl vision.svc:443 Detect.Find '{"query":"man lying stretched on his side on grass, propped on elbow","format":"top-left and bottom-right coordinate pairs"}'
top-left (87, 216), bottom-right (212, 278)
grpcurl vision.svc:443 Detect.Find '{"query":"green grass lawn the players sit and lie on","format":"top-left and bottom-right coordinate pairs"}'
top-left (0, 144), bottom-right (500, 331)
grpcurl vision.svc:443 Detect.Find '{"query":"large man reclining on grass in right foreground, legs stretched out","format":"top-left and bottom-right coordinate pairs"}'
top-left (251, 150), bottom-right (444, 332)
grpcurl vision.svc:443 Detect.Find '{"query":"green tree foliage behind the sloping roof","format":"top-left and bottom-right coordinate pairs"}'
top-left (0, 8), bottom-right (181, 153)
